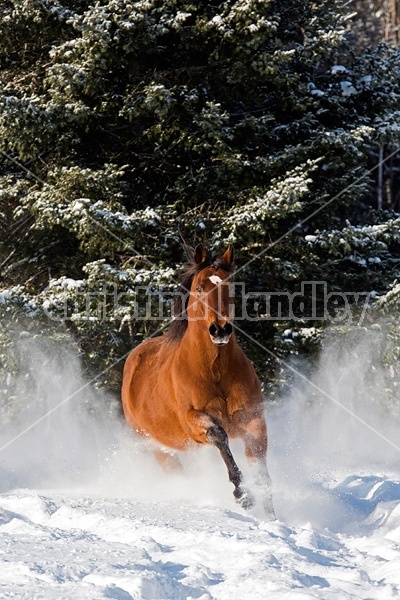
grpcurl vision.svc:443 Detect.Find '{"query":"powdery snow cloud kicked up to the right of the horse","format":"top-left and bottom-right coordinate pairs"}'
top-left (268, 328), bottom-right (400, 530)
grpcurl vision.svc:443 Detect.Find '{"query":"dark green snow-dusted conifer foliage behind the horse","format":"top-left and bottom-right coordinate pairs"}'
top-left (0, 0), bottom-right (400, 398)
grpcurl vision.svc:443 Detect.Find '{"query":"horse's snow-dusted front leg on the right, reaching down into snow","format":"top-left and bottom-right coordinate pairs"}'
top-left (242, 416), bottom-right (275, 519)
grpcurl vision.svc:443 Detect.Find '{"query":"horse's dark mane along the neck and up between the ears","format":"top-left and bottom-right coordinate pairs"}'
top-left (166, 244), bottom-right (234, 342)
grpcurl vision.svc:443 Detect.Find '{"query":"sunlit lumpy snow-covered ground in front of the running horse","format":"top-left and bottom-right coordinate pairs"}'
top-left (0, 475), bottom-right (400, 600)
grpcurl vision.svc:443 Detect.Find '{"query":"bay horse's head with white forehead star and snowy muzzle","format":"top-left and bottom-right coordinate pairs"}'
top-left (187, 244), bottom-right (234, 346)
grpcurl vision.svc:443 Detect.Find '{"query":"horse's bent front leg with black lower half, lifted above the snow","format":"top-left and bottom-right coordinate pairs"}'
top-left (186, 409), bottom-right (255, 510)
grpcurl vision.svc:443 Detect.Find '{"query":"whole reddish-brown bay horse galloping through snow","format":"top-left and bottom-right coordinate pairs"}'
top-left (122, 244), bottom-right (274, 518)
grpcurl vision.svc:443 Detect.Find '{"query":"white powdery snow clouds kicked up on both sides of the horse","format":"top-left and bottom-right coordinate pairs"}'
top-left (0, 333), bottom-right (400, 529)
